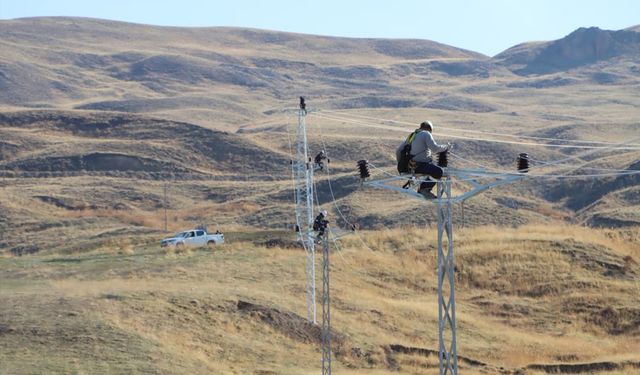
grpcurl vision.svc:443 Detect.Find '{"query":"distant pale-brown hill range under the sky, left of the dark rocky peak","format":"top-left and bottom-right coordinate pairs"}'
top-left (0, 18), bottom-right (484, 119)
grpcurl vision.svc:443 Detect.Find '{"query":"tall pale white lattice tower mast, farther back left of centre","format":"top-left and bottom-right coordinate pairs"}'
top-left (293, 108), bottom-right (317, 323)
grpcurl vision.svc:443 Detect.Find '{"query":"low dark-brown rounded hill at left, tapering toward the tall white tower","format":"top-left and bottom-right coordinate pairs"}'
top-left (0, 110), bottom-right (289, 175)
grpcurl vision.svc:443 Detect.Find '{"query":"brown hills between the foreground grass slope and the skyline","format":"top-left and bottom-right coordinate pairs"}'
top-left (0, 18), bottom-right (640, 253)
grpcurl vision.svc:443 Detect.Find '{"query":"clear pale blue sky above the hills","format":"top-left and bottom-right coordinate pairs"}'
top-left (0, 0), bottom-right (640, 56)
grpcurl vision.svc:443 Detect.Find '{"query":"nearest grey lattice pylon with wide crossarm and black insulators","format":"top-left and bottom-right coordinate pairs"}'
top-left (358, 162), bottom-right (529, 375)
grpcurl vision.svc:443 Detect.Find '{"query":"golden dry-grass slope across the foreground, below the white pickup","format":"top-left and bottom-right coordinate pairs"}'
top-left (0, 226), bottom-right (640, 374)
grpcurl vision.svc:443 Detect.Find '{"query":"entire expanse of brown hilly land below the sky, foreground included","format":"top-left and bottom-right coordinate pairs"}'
top-left (0, 17), bottom-right (640, 375)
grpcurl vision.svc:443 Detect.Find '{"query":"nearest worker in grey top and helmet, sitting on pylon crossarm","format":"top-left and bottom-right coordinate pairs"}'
top-left (396, 121), bottom-right (451, 199)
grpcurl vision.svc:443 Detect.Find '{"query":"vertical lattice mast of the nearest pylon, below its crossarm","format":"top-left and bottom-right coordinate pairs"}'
top-left (437, 178), bottom-right (458, 375)
